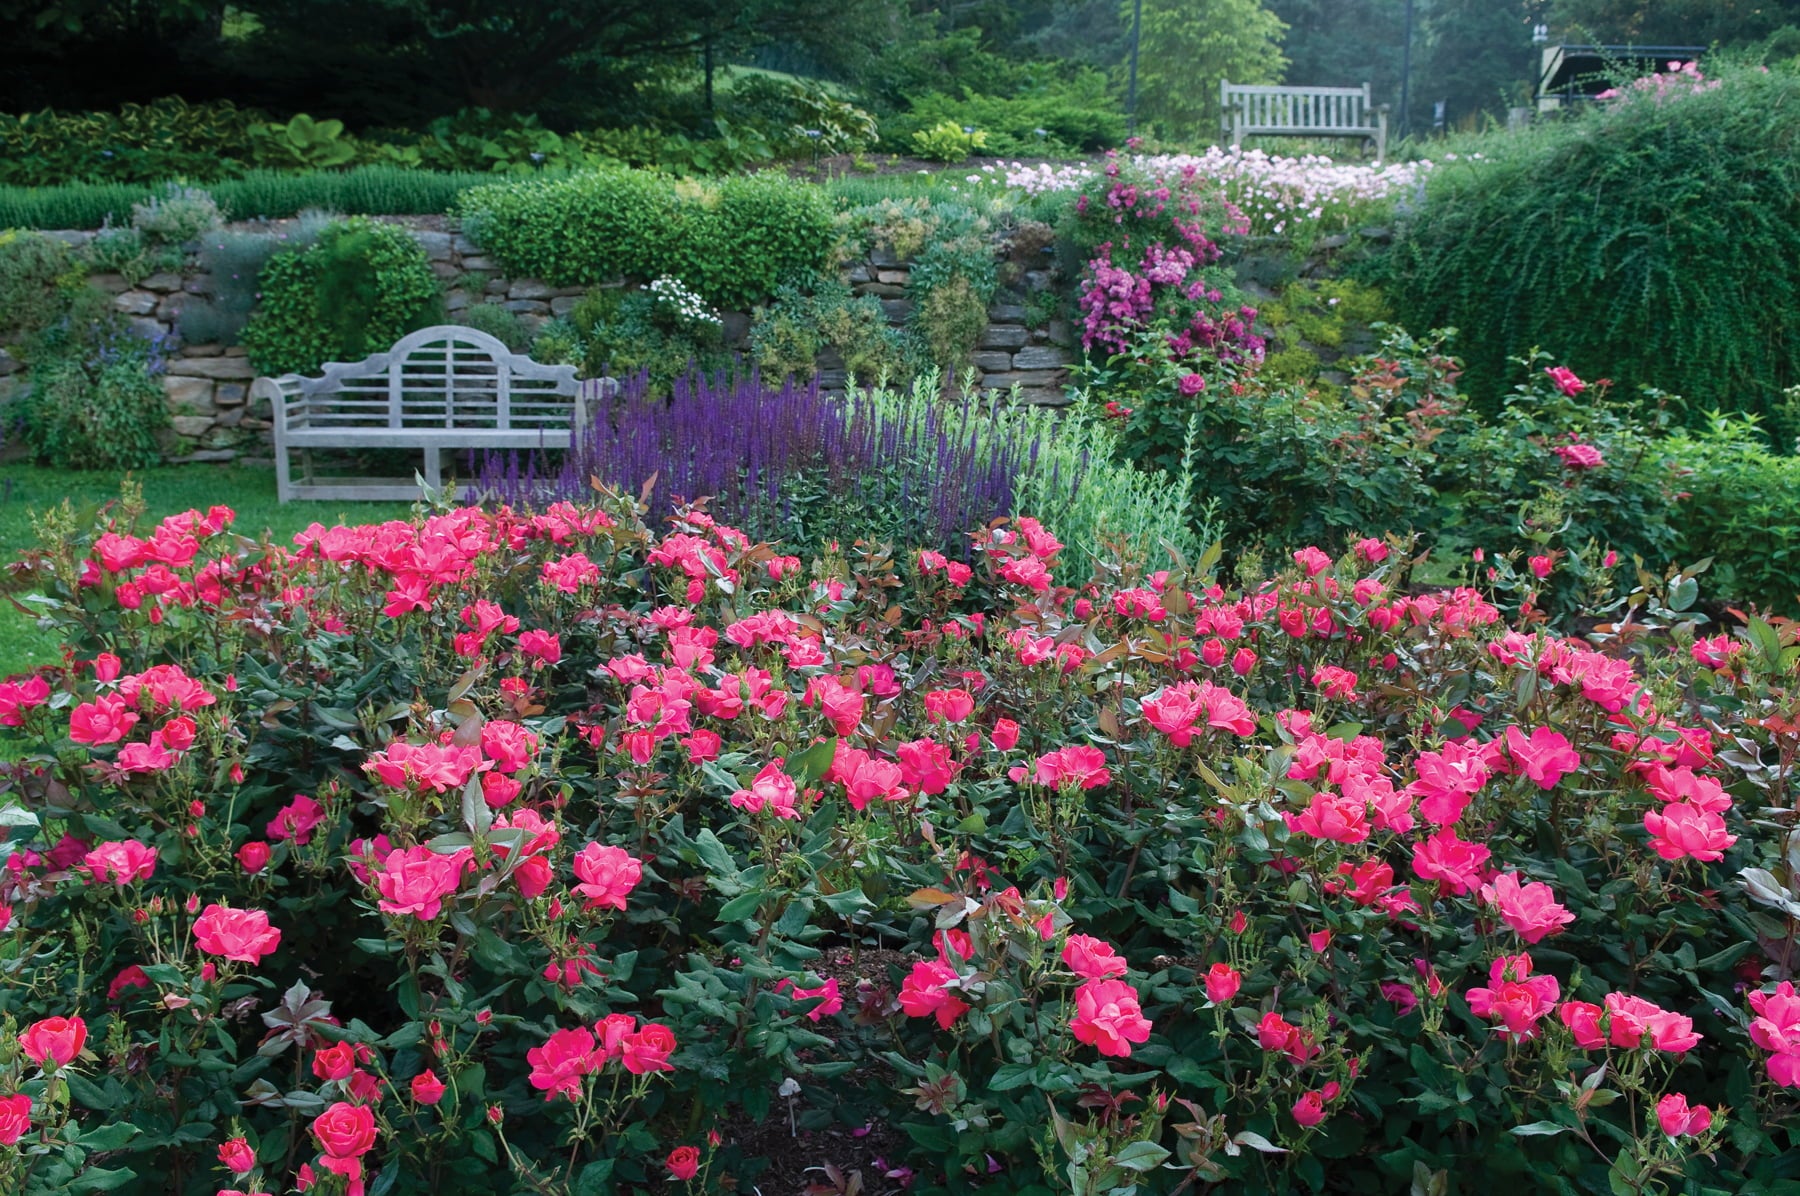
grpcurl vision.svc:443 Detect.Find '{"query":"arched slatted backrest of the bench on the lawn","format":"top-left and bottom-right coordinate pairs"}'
top-left (283, 324), bottom-right (576, 429)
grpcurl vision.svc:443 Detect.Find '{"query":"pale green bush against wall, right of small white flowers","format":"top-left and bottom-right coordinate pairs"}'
top-left (751, 277), bottom-right (904, 384)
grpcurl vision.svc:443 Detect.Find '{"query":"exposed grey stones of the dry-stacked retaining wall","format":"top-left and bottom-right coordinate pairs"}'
top-left (0, 222), bottom-right (1073, 463)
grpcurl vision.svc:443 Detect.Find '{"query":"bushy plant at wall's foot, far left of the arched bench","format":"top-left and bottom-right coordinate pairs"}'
top-left (18, 309), bottom-right (169, 470)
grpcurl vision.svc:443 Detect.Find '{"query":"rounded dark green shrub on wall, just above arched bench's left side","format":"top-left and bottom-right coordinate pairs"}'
top-left (243, 216), bottom-right (441, 375)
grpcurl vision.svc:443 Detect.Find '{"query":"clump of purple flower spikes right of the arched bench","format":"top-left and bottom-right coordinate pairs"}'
top-left (477, 371), bottom-right (1046, 551)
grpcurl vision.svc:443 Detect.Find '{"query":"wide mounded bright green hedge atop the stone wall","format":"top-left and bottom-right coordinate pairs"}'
top-left (457, 169), bottom-right (833, 310)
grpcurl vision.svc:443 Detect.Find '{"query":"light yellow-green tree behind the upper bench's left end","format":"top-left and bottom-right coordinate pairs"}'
top-left (1123, 0), bottom-right (1287, 140)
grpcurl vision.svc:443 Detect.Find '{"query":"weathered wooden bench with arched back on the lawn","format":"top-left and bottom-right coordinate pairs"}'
top-left (250, 324), bottom-right (587, 503)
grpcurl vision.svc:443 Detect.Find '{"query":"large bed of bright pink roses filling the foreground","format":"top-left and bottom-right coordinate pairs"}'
top-left (0, 489), bottom-right (1800, 1194)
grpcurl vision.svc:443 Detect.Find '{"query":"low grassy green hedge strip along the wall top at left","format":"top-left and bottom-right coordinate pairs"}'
top-left (0, 166), bottom-right (493, 229)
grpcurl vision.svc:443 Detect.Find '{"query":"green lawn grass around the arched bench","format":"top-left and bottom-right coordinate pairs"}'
top-left (0, 465), bottom-right (410, 677)
